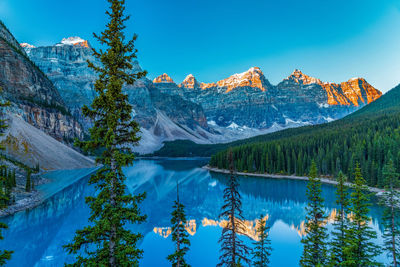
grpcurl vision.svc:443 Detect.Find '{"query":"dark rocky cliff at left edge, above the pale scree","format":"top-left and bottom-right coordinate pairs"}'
top-left (0, 23), bottom-right (82, 140)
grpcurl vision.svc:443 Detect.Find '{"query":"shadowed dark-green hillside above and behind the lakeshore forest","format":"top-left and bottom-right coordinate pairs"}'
top-left (153, 85), bottom-right (400, 159)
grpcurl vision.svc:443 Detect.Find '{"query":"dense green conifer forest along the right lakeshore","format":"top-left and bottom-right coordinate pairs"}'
top-left (210, 113), bottom-right (400, 187)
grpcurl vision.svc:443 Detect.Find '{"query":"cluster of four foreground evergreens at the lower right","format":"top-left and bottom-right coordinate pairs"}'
top-left (300, 161), bottom-right (400, 266)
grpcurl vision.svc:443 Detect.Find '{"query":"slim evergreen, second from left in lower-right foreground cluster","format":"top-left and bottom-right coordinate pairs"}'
top-left (329, 171), bottom-right (349, 266)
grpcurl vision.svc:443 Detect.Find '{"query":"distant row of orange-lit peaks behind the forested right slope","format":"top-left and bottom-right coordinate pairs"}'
top-left (154, 67), bottom-right (382, 130)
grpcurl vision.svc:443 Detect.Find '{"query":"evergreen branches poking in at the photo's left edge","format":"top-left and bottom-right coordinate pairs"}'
top-left (0, 87), bottom-right (13, 266)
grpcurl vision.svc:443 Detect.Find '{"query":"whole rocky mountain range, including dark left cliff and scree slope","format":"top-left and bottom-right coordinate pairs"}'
top-left (0, 17), bottom-right (382, 168)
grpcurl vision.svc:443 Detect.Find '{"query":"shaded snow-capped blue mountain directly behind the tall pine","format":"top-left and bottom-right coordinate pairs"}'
top-left (24, 37), bottom-right (212, 153)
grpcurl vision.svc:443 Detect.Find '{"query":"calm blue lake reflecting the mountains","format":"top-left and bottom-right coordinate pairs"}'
top-left (0, 159), bottom-right (387, 267)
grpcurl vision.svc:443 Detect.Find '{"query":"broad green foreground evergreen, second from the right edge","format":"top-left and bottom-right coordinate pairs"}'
top-left (343, 163), bottom-right (380, 266)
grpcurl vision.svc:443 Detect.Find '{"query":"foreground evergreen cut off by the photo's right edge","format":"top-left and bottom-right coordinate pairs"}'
top-left (382, 160), bottom-right (400, 266)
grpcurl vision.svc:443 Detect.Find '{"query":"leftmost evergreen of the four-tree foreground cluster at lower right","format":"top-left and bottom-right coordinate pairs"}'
top-left (300, 161), bottom-right (328, 266)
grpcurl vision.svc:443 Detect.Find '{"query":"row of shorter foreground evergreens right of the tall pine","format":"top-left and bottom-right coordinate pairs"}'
top-left (168, 156), bottom-right (400, 267)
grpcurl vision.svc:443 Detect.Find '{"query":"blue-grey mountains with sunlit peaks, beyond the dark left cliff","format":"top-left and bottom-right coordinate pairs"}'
top-left (21, 37), bottom-right (382, 153)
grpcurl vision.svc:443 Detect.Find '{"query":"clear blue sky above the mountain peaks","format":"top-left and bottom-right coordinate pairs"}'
top-left (0, 0), bottom-right (400, 92)
